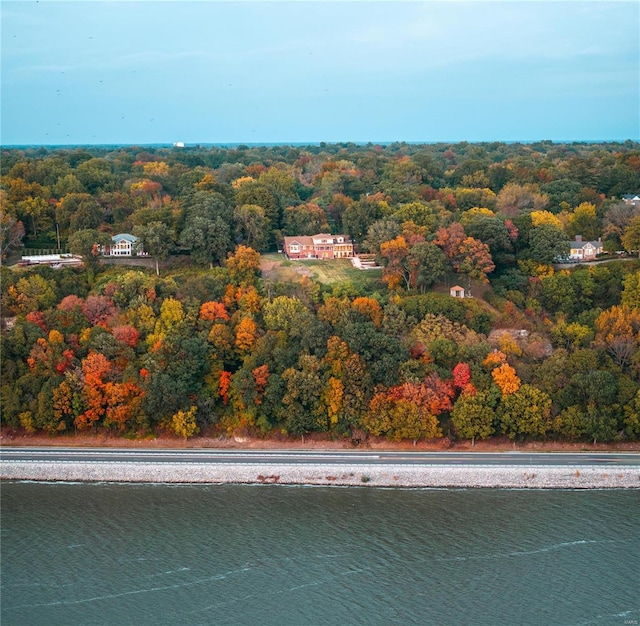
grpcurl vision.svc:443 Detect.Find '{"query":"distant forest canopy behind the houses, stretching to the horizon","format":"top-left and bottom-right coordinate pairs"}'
top-left (0, 141), bottom-right (640, 266)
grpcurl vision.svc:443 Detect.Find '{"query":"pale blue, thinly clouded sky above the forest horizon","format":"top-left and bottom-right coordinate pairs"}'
top-left (0, 0), bottom-right (640, 145)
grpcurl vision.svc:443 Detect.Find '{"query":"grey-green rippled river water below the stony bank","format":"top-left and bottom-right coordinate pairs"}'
top-left (0, 482), bottom-right (640, 626)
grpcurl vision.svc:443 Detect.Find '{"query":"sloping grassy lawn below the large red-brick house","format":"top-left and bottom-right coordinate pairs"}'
top-left (262, 253), bottom-right (381, 285)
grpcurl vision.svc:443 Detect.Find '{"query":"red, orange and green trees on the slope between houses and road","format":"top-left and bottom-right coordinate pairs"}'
top-left (1, 251), bottom-right (640, 441)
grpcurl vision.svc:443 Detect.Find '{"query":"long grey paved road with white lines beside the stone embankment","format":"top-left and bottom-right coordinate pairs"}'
top-left (0, 446), bottom-right (640, 467)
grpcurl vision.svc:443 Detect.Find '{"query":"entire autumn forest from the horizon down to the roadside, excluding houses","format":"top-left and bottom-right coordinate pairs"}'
top-left (0, 141), bottom-right (640, 442)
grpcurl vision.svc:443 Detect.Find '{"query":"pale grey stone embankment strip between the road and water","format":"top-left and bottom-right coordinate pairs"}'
top-left (5, 460), bottom-right (640, 489)
